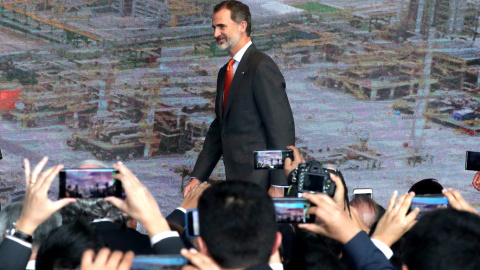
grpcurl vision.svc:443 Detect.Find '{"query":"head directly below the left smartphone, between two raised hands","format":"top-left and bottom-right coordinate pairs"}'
top-left (61, 198), bottom-right (124, 224)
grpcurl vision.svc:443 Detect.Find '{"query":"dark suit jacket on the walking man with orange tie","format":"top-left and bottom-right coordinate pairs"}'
top-left (192, 44), bottom-right (295, 188)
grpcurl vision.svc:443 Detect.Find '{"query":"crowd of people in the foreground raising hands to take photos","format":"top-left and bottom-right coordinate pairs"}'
top-left (0, 147), bottom-right (480, 270)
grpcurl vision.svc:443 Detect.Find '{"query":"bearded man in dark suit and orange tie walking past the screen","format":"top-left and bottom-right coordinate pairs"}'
top-left (184, 0), bottom-right (295, 195)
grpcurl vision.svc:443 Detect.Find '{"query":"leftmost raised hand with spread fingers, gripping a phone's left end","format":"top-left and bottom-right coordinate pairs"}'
top-left (16, 157), bottom-right (76, 235)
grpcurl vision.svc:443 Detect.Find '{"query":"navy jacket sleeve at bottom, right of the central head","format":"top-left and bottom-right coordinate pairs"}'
top-left (344, 231), bottom-right (396, 270)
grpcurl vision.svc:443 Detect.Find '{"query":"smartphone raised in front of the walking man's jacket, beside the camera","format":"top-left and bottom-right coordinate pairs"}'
top-left (253, 150), bottom-right (293, 170)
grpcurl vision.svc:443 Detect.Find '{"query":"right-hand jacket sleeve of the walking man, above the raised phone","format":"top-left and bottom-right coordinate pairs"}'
top-left (253, 58), bottom-right (295, 186)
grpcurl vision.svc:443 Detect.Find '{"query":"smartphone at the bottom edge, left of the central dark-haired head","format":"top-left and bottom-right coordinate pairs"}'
top-left (130, 255), bottom-right (188, 270)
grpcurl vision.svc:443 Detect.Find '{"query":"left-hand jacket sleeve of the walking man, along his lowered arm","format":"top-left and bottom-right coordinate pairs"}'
top-left (192, 117), bottom-right (222, 181)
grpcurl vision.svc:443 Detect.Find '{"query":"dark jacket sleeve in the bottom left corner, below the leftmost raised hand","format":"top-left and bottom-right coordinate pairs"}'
top-left (0, 238), bottom-right (32, 270)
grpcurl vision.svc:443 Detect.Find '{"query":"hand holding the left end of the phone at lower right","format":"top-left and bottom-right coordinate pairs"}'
top-left (372, 191), bottom-right (420, 247)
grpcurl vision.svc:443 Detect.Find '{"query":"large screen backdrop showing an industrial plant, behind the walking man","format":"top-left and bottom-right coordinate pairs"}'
top-left (0, 0), bottom-right (480, 213)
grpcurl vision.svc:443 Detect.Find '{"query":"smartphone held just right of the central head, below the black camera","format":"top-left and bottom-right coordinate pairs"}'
top-left (273, 198), bottom-right (315, 223)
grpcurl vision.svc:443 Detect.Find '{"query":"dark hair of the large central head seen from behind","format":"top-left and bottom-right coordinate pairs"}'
top-left (198, 181), bottom-right (277, 268)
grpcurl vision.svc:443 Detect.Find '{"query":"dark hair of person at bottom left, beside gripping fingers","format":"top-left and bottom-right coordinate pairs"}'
top-left (35, 219), bottom-right (104, 270)
